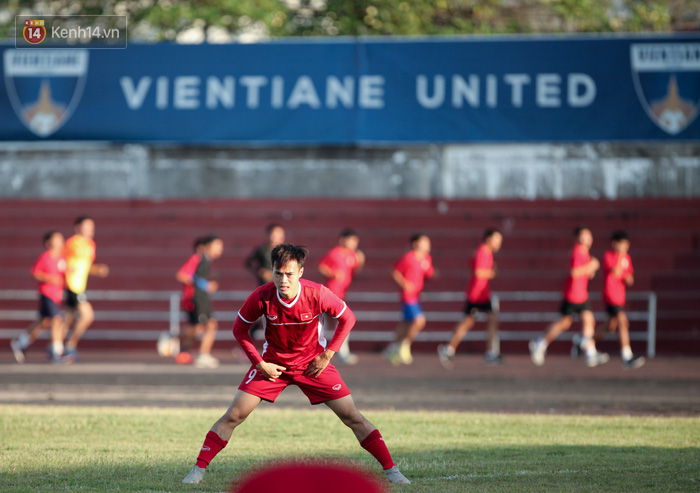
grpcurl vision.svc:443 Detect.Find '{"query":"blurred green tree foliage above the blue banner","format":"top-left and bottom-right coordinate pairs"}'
top-left (0, 0), bottom-right (700, 42)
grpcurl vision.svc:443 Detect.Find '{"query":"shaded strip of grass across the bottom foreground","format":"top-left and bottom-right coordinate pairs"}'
top-left (0, 445), bottom-right (700, 493)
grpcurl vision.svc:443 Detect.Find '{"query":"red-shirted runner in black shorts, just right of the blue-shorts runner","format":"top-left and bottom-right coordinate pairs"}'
top-left (438, 229), bottom-right (503, 369)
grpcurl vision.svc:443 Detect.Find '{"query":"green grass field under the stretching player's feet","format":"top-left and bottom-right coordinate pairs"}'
top-left (0, 406), bottom-right (700, 492)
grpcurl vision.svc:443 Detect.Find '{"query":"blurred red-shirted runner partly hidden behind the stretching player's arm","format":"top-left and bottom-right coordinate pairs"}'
top-left (318, 229), bottom-right (365, 365)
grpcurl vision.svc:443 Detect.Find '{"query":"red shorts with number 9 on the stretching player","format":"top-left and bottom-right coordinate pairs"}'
top-left (238, 363), bottom-right (350, 404)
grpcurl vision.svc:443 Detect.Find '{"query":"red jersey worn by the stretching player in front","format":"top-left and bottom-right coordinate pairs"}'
top-left (233, 279), bottom-right (355, 370)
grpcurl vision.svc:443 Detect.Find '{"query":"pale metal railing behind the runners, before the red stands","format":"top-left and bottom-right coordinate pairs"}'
top-left (0, 290), bottom-right (657, 357)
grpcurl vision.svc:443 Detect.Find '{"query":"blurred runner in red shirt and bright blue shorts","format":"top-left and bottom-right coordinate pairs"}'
top-left (384, 233), bottom-right (435, 366)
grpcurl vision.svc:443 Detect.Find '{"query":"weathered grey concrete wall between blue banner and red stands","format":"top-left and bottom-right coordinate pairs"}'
top-left (0, 142), bottom-right (700, 200)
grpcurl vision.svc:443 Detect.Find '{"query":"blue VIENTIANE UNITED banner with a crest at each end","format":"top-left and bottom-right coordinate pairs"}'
top-left (0, 35), bottom-right (700, 145)
